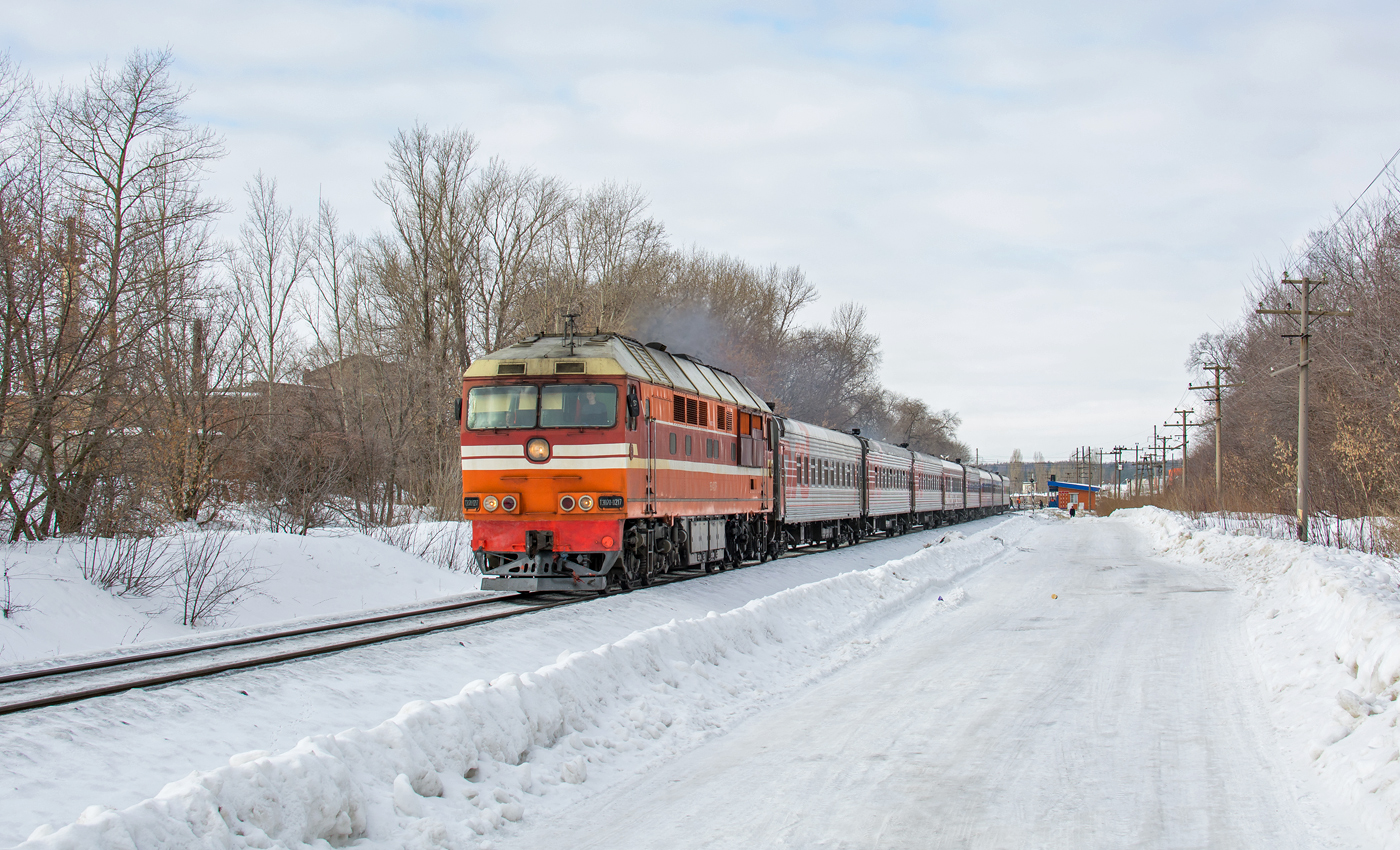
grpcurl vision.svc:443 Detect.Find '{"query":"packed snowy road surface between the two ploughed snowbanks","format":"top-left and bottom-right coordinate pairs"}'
top-left (501, 521), bottom-right (1366, 850)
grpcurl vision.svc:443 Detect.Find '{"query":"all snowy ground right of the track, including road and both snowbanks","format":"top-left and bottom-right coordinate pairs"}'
top-left (0, 510), bottom-right (1400, 850)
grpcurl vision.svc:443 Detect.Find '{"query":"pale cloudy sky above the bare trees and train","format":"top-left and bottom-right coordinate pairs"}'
top-left (0, 0), bottom-right (1400, 459)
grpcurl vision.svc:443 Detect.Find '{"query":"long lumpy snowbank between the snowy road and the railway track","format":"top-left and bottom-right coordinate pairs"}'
top-left (22, 518), bottom-right (1036, 850)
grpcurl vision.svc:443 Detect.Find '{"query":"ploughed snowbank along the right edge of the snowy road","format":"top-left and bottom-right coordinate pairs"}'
top-left (1113, 507), bottom-right (1400, 847)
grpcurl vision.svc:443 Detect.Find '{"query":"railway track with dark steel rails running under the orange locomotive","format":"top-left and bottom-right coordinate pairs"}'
top-left (0, 518), bottom-right (996, 716)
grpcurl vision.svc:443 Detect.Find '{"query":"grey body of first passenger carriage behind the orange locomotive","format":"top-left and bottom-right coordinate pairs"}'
top-left (781, 419), bottom-right (861, 522)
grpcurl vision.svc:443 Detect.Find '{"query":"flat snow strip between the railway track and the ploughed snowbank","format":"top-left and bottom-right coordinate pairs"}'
top-left (0, 520), bottom-right (998, 847)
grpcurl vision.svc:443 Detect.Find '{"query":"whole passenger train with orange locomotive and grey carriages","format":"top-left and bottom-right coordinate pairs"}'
top-left (458, 333), bottom-right (1009, 591)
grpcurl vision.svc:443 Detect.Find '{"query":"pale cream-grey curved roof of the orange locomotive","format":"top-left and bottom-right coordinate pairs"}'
top-left (463, 333), bottom-right (770, 412)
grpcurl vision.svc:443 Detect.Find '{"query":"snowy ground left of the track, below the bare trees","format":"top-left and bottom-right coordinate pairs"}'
top-left (0, 522), bottom-right (480, 669)
